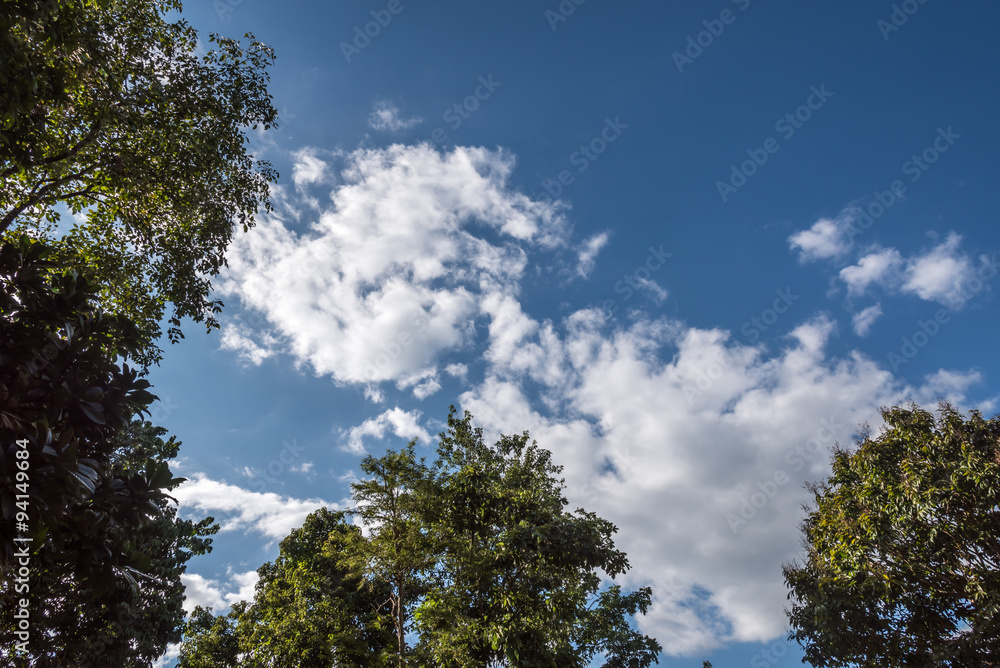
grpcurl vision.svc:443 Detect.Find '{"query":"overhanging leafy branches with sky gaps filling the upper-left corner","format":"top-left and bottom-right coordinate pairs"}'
top-left (0, 0), bottom-right (277, 366)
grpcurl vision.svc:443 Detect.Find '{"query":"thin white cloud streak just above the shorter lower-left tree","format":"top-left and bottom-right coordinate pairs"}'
top-left (172, 473), bottom-right (340, 540)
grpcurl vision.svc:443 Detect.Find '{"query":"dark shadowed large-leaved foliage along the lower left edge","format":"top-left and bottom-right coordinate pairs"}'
top-left (0, 236), bottom-right (213, 668)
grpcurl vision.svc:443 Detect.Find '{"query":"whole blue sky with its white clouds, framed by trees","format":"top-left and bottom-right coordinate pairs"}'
top-left (151, 0), bottom-right (1000, 668)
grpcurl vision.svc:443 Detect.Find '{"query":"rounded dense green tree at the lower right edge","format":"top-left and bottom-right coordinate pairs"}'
top-left (784, 403), bottom-right (1000, 668)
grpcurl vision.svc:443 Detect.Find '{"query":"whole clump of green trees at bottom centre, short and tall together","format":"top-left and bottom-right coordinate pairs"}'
top-left (181, 408), bottom-right (661, 668)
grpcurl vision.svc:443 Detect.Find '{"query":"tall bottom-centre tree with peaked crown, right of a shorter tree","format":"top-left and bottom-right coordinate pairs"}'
top-left (415, 407), bottom-right (662, 668)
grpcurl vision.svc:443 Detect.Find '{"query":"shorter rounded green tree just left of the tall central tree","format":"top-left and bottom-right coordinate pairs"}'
top-left (180, 508), bottom-right (394, 668)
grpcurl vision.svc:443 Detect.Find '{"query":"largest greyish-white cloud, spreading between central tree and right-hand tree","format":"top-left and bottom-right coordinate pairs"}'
top-left (452, 311), bottom-right (976, 654)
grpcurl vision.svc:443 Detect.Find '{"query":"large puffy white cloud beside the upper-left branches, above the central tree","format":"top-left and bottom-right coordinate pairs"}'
top-left (218, 144), bottom-right (568, 396)
